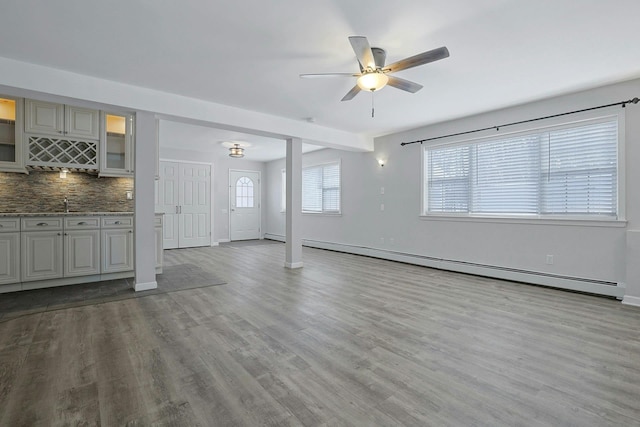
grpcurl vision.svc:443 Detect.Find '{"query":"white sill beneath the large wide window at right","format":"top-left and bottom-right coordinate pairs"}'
top-left (420, 214), bottom-right (627, 228)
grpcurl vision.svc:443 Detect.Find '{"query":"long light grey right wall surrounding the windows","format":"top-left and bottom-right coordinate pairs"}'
top-left (266, 80), bottom-right (640, 302)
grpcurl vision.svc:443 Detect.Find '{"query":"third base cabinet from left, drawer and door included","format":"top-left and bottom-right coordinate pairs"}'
top-left (63, 217), bottom-right (100, 277)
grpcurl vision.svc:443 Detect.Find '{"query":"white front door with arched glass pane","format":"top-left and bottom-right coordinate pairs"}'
top-left (229, 170), bottom-right (261, 241)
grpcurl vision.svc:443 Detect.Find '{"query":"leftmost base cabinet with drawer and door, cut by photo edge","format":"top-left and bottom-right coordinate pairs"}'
top-left (0, 218), bottom-right (20, 290)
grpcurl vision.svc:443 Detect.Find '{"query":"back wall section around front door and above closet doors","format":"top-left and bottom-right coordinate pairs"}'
top-left (160, 146), bottom-right (266, 243)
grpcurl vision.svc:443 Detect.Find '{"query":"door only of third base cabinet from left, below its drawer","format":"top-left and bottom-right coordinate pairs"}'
top-left (64, 230), bottom-right (100, 277)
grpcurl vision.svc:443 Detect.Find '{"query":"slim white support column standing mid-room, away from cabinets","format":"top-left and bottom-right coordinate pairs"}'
top-left (284, 138), bottom-right (302, 268)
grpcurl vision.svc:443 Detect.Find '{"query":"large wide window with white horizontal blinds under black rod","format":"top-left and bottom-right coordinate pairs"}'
top-left (424, 117), bottom-right (618, 218)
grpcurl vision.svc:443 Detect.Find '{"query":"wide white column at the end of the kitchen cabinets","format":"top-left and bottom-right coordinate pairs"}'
top-left (133, 112), bottom-right (158, 291)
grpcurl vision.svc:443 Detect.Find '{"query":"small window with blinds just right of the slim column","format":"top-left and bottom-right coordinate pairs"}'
top-left (302, 162), bottom-right (340, 213)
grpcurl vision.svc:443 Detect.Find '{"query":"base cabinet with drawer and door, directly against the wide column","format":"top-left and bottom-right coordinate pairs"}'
top-left (101, 216), bottom-right (133, 274)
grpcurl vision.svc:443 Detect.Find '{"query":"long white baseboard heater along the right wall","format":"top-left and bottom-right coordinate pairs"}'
top-left (264, 233), bottom-right (624, 298)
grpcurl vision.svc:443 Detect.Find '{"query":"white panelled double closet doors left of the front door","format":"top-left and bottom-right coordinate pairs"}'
top-left (156, 161), bottom-right (211, 249)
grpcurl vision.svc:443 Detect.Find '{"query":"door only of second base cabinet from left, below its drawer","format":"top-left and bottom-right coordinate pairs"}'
top-left (21, 231), bottom-right (63, 282)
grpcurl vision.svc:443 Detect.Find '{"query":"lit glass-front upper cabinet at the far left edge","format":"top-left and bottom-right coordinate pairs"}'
top-left (0, 95), bottom-right (26, 173)
